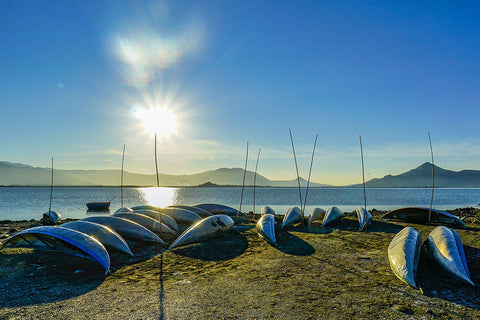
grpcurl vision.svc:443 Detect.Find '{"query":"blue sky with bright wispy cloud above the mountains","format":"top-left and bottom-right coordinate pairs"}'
top-left (0, 0), bottom-right (480, 185)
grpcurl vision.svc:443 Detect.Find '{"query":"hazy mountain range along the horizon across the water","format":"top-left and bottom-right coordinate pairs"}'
top-left (0, 161), bottom-right (480, 188)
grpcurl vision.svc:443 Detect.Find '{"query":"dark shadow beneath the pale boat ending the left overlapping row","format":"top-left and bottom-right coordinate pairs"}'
top-left (171, 231), bottom-right (248, 261)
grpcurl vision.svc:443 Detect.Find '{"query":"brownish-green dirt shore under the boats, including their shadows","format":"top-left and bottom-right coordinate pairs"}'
top-left (0, 208), bottom-right (480, 319)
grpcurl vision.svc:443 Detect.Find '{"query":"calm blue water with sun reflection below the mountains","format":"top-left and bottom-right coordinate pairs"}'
top-left (0, 187), bottom-right (480, 220)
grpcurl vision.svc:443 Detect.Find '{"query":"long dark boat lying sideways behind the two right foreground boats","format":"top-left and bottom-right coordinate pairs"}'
top-left (382, 207), bottom-right (465, 229)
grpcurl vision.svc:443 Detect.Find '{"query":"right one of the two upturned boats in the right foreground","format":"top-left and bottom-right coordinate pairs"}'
top-left (427, 226), bottom-right (475, 286)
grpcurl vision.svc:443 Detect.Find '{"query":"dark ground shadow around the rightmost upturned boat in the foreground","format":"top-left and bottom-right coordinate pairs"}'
top-left (417, 245), bottom-right (480, 310)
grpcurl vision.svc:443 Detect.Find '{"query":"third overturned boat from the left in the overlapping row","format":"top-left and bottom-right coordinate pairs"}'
top-left (79, 216), bottom-right (165, 245)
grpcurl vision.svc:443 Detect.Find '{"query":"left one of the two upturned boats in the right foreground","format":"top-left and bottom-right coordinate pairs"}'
top-left (388, 227), bottom-right (422, 288)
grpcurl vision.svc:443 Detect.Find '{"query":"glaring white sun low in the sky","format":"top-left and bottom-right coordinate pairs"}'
top-left (132, 106), bottom-right (177, 137)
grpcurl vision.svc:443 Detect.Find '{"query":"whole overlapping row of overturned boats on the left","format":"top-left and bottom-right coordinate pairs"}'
top-left (2, 204), bottom-right (238, 274)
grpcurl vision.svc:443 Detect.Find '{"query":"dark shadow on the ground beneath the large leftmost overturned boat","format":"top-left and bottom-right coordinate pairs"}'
top-left (0, 250), bottom-right (105, 309)
